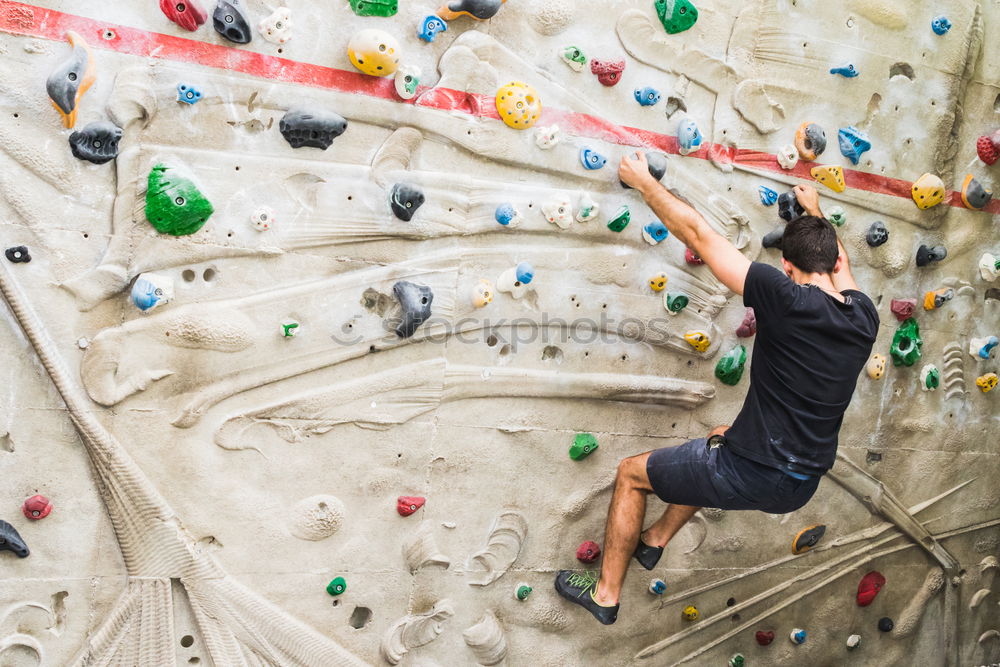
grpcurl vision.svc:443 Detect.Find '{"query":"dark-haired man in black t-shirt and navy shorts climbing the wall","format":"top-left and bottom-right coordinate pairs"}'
top-left (555, 154), bottom-right (879, 625)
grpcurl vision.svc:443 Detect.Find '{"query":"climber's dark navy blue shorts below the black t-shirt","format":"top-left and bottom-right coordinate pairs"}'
top-left (646, 438), bottom-right (820, 514)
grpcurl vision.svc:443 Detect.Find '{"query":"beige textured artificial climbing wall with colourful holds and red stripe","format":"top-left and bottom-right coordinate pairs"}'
top-left (0, 0), bottom-right (1000, 666)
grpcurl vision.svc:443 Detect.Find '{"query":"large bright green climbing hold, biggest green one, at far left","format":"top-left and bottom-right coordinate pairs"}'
top-left (146, 164), bottom-right (215, 236)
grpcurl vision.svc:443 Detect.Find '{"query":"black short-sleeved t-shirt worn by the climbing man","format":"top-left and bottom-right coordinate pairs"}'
top-left (726, 262), bottom-right (879, 475)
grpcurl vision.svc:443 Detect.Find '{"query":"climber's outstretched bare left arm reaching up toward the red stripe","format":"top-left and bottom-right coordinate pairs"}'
top-left (618, 153), bottom-right (752, 295)
